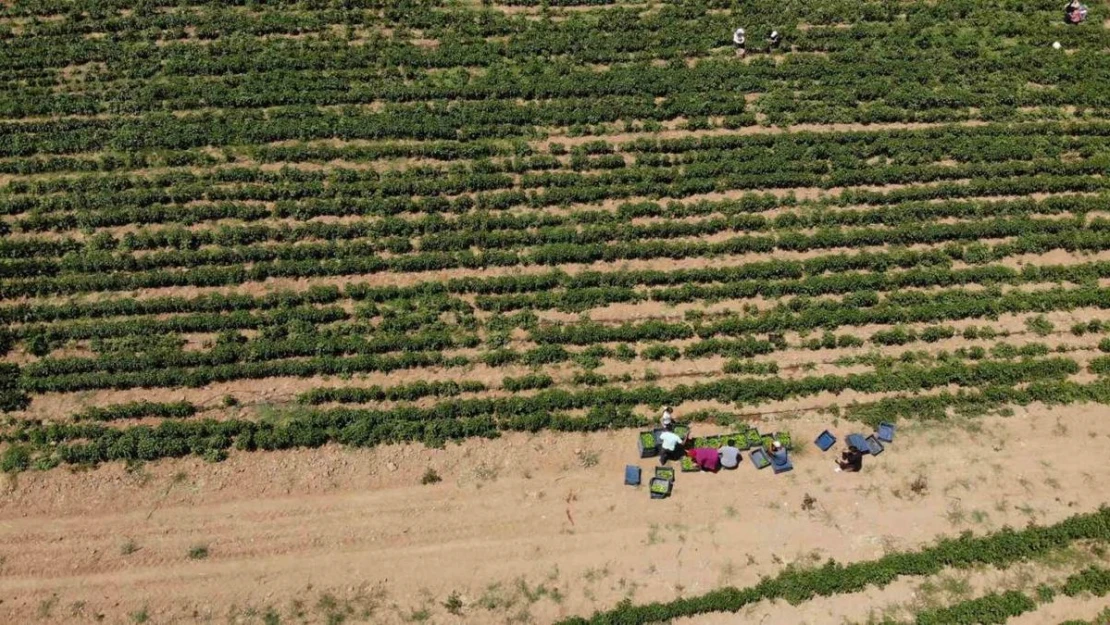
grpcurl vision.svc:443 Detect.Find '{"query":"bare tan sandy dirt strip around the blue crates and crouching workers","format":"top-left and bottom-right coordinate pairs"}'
top-left (0, 406), bottom-right (1110, 625)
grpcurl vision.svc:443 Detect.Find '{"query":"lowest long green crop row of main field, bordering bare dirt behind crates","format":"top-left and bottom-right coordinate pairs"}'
top-left (6, 359), bottom-right (1083, 462)
